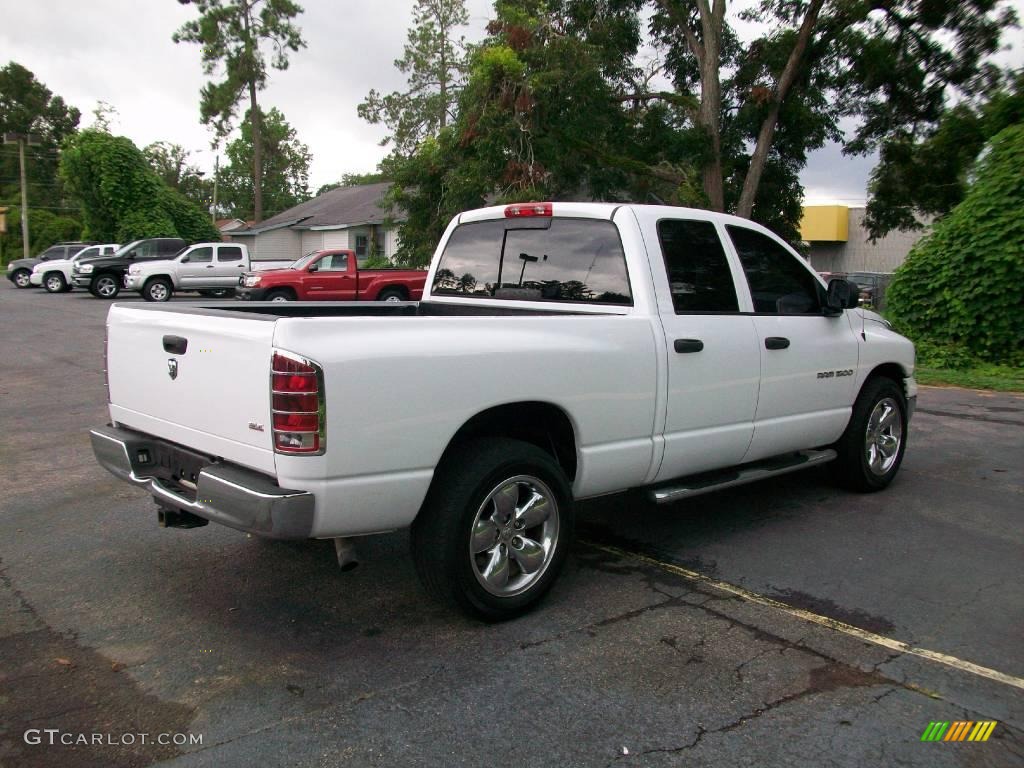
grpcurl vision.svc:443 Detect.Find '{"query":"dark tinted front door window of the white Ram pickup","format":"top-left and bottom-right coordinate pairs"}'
top-left (726, 226), bottom-right (821, 314)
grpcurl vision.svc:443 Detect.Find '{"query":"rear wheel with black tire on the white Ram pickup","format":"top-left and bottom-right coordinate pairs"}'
top-left (412, 437), bottom-right (573, 622)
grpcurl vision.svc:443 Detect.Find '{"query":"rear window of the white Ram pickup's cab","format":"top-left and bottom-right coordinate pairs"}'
top-left (431, 218), bottom-right (633, 304)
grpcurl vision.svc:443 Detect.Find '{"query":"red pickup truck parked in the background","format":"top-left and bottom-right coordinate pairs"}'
top-left (237, 250), bottom-right (427, 301)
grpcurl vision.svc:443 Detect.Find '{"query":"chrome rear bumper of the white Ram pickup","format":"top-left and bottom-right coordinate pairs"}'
top-left (89, 426), bottom-right (314, 539)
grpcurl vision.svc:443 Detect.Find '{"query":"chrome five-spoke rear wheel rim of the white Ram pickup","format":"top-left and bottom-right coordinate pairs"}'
top-left (469, 475), bottom-right (558, 597)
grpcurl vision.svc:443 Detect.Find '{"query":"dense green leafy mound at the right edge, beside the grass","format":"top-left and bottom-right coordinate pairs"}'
top-left (886, 124), bottom-right (1024, 368)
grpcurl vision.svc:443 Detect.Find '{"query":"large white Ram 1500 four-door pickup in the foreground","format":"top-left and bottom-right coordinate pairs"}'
top-left (92, 203), bottom-right (916, 620)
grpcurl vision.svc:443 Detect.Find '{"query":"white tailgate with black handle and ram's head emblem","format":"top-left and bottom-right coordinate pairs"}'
top-left (106, 305), bottom-right (274, 473)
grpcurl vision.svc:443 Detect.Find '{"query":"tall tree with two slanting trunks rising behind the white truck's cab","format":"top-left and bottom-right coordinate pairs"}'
top-left (653, 0), bottom-right (1015, 222)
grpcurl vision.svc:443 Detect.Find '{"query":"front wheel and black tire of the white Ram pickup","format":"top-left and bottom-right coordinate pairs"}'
top-left (831, 377), bottom-right (907, 493)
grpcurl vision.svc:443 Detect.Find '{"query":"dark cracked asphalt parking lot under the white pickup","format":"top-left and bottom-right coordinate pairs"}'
top-left (0, 282), bottom-right (1024, 766)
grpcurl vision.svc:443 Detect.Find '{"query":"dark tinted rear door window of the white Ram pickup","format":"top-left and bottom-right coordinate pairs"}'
top-left (657, 219), bottom-right (739, 314)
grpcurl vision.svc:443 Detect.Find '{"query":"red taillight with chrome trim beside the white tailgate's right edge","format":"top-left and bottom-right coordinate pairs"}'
top-left (270, 350), bottom-right (327, 455)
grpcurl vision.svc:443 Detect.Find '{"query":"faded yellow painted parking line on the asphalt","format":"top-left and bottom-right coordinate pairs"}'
top-left (584, 542), bottom-right (1024, 690)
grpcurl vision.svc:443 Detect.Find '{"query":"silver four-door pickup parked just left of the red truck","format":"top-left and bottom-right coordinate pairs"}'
top-left (124, 243), bottom-right (249, 301)
